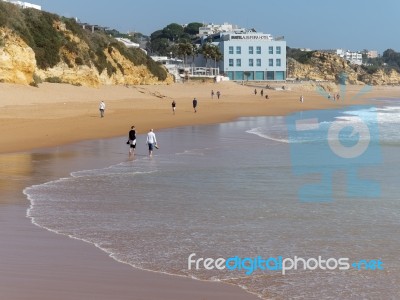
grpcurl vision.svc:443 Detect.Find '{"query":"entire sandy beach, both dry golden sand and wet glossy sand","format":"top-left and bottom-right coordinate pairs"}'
top-left (0, 82), bottom-right (400, 299)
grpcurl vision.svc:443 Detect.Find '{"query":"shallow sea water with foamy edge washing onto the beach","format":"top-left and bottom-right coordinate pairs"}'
top-left (25, 100), bottom-right (400, 299)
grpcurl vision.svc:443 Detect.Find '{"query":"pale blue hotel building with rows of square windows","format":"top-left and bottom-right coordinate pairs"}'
top-left (202, 30), bottom-right (286, 81)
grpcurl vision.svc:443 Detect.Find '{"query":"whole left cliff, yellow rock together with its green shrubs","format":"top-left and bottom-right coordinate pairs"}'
top-left (0, 1), bottom-right (173, 86)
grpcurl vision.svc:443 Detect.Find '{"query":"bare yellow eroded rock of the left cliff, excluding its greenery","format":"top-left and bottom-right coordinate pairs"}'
top-left (0, 23), bottom-right (173, 87)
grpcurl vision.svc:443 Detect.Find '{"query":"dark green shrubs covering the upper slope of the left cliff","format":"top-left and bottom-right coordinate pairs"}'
top-left (0, 1), bottom-right (167, 81)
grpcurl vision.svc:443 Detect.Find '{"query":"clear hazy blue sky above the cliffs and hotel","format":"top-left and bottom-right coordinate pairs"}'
top-left (32, 0), bottom-right (400, 52)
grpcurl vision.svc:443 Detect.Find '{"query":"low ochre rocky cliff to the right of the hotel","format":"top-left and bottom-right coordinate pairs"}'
top-left (287, 52), bottom-right (400, 85)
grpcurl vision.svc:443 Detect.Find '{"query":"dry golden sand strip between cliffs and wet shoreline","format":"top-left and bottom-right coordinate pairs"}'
top-left (0, 82), bottom-right (399, 153)
